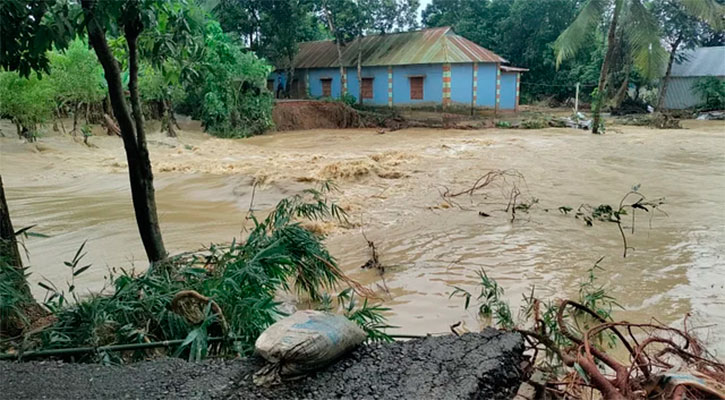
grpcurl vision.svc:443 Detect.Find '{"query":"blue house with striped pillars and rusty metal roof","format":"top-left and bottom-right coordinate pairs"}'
top-left (269, 27), bottom-right (528, 110)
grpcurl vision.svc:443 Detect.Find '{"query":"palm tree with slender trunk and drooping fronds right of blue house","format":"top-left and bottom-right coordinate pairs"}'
top-left (554, 0), bottom-right (722, 133)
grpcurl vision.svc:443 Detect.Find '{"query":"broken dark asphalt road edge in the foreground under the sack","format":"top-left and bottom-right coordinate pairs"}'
top-left (0, 329), bottom-right (523, 400)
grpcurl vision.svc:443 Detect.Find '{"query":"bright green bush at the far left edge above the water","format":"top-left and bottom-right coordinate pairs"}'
top-left (0, 71), bottom-right (55, 140)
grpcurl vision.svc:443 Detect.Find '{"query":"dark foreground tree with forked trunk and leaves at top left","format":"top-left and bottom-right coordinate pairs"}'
top-left (0, 0), bottom-right (166, 262)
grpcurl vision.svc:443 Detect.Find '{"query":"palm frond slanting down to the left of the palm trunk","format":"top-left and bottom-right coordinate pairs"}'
top-left (554, 0), bottom-right (609, 68)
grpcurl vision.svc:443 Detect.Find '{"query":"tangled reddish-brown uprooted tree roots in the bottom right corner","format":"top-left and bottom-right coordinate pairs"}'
top-left (518, 300), bottom-right (725, 400)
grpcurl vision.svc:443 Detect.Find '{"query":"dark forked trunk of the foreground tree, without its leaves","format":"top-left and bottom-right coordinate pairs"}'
top-left (82, 0), bottom-right (166, 262)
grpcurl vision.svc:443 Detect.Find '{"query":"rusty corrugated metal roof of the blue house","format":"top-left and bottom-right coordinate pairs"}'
top-left (295, 27), bottom-right (508, 68)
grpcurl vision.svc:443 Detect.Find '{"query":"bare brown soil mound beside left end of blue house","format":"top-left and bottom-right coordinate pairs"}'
top-left (272, 100), bottom-right (360, 131)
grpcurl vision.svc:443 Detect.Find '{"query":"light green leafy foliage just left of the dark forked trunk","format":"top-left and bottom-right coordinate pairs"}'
top-left (48, 38), bottom-right (106, 108)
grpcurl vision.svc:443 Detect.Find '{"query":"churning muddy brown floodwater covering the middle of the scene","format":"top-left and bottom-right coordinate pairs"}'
top-left (0, 121), bottom-right (725, 355)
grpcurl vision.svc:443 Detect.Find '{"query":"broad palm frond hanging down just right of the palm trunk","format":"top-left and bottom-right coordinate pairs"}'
top-left (622, 0), bottom-right (668, 79)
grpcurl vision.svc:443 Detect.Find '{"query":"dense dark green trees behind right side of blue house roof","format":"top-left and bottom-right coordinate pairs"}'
top-left (423, 0), bottom-right (604, 103)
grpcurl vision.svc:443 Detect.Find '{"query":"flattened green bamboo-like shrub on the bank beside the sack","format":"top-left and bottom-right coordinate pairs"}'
top-left (29, 190), bottom-right (378, 361)
